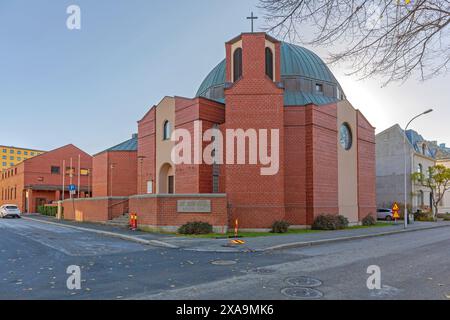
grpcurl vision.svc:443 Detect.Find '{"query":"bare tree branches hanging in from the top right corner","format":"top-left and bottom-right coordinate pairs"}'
top-left (259, 0), bottom-right (450, 85)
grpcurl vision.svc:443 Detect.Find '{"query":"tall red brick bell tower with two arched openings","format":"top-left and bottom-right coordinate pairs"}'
top-left (224, 33), bottom-right (285, 228)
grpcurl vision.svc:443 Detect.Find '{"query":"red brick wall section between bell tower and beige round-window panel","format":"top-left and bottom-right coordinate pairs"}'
top-left (284, 104), bottom-right (339, 225)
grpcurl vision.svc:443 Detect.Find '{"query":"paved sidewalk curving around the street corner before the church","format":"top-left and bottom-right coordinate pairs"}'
top-left (24, 215), bottom-right (450, 252)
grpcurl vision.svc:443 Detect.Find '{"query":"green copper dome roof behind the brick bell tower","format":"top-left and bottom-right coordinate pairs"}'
top-left (196, 42), bottom-right (345, 106)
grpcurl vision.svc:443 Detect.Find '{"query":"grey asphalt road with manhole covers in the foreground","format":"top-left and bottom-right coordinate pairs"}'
top-left (0, 219), bottom-right (450, 300)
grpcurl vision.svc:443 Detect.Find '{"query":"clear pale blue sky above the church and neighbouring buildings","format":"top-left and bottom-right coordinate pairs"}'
top-left (0, 0), bottom-right (450, 154)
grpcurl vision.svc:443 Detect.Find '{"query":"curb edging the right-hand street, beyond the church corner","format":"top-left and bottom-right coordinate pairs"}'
top-left (259, 224), bottom-right (450, 252)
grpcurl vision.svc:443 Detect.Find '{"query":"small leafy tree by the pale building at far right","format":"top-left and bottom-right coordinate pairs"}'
top-left (411, 165), bottom-right (450, 219)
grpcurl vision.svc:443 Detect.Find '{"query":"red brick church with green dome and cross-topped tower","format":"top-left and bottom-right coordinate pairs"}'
top-left (74, 33), bottom-right (376, 230)
